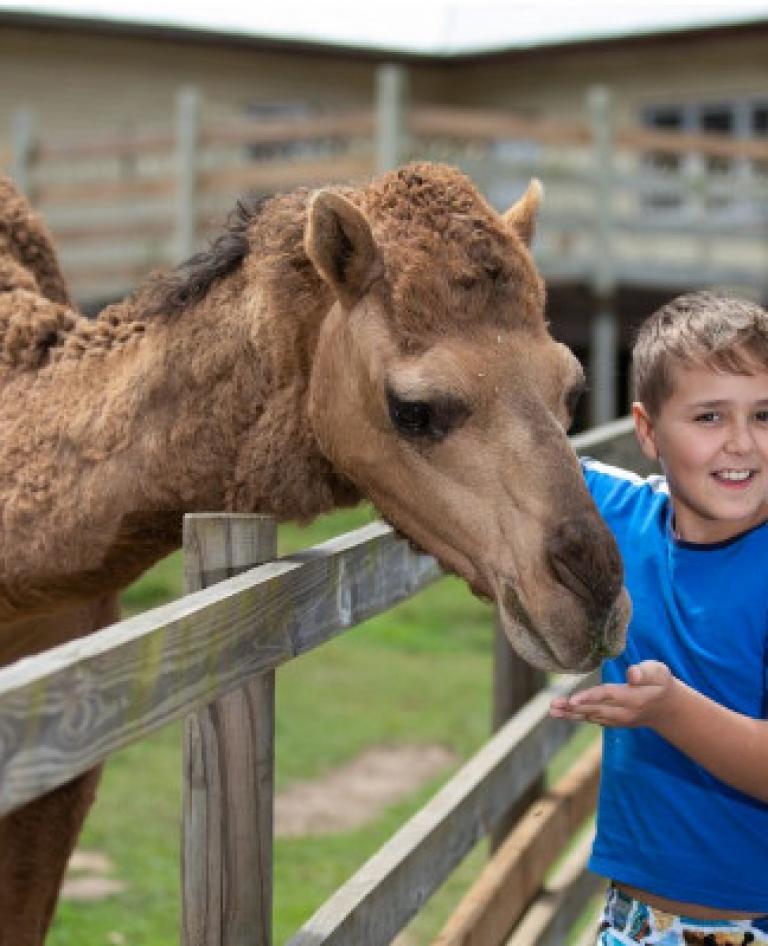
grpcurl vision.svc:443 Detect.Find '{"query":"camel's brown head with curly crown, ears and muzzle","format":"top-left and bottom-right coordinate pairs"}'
top-left (305, 165), bottom-right (629, 671)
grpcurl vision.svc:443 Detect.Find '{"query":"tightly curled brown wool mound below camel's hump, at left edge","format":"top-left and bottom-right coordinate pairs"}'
top-left (0, 288), bottom-right (77, 369)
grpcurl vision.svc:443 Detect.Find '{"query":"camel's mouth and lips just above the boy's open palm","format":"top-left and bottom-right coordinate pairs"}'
top-left (496, 580), bottom-right (631, 673)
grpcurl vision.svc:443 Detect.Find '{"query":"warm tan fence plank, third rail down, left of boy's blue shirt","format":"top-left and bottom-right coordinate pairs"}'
top-left (434, 743), bottom-right (600, 946)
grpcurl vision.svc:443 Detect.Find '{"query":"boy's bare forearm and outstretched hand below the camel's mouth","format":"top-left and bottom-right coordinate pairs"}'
top-left (551, 660), bottom-right (768, 802)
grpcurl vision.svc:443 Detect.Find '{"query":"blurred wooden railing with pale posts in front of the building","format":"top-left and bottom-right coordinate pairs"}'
top-left (0, 66), bottom-right (768, 303)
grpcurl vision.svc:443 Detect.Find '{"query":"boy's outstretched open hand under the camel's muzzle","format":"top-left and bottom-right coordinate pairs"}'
top-left (549, 660), bottom-right (675, 726)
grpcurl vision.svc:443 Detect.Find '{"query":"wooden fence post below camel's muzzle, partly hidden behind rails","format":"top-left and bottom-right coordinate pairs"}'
top-left (491, 615), bottom-right (547, 853)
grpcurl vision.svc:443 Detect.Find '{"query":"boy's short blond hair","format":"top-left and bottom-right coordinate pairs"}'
top-left (632, 292), bottom-right (768, 416)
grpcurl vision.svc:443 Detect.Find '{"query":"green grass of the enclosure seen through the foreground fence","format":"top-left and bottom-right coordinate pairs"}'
top-left (48, 507), bottom-right (592, 946)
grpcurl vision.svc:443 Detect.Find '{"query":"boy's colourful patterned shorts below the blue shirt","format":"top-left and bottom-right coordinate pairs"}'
top-left (596, 887), bottom-right (768, 946)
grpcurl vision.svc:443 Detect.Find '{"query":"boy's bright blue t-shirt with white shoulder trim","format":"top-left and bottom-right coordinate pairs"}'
top-left (582, 460), bottom-right (768, 913)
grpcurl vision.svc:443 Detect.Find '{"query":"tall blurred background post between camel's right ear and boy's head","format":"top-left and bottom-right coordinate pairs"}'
top-left (589, 86), bottom-right (619, 426)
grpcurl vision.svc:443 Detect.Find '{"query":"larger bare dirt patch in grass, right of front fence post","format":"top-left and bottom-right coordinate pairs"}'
top-left (275, 745), bottom-right (457, 838)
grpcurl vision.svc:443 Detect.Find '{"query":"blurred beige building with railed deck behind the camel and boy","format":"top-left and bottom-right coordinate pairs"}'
top-left (0, 4), bottom-right (768, 420)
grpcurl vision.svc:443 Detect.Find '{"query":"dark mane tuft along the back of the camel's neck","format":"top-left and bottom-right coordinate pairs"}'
top-left (144, 195), bottom-right (269, 316)
